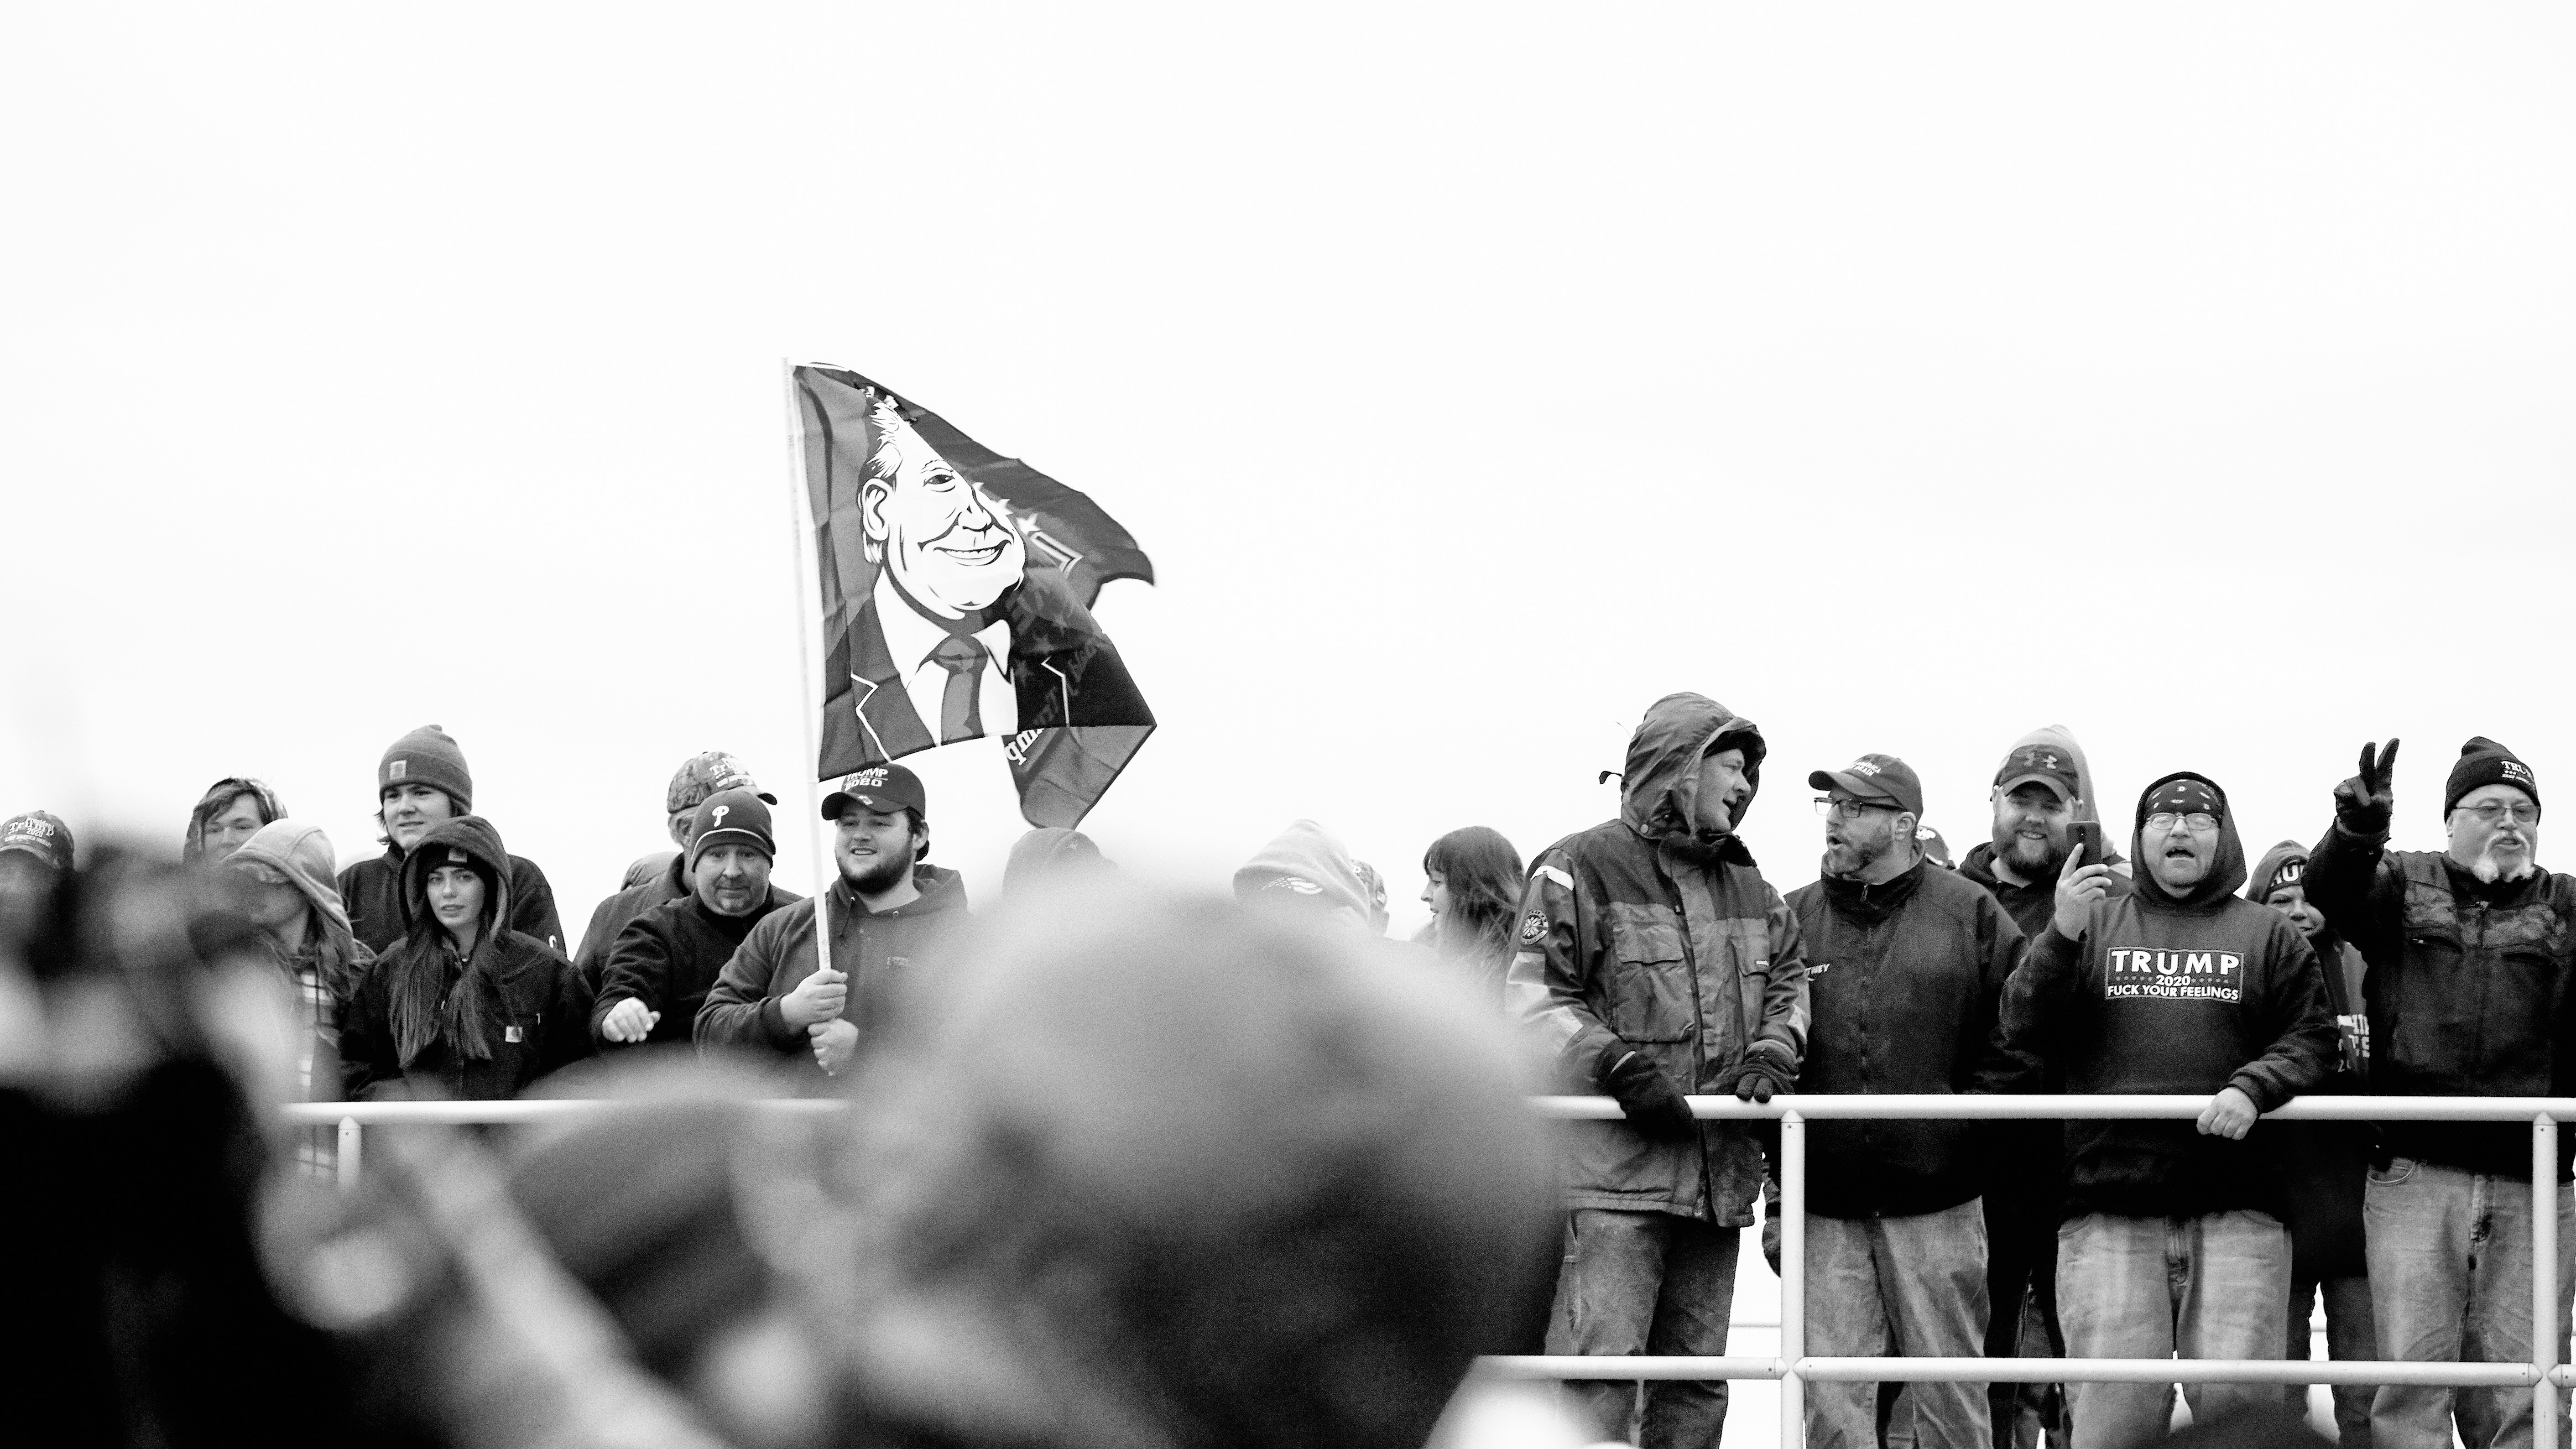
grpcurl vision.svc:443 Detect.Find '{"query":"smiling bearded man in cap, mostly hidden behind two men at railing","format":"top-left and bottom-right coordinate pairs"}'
top-left (1958, 726), bottom-right (2128, 1449)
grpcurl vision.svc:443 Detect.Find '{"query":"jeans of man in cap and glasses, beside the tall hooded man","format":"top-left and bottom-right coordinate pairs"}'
top-left (1806, 1199), bottom-right (1994, 1449)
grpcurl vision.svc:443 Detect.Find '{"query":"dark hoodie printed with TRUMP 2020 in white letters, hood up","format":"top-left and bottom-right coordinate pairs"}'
top-left (2004, 772), bottom-right (2334, 1217)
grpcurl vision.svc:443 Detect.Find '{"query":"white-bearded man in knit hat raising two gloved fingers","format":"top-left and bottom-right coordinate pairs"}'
top-left (2303, 736), bottom-right (2576, 1449)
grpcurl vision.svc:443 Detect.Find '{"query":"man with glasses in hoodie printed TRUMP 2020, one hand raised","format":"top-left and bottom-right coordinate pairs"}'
top-left (1991, 772), bottom-right (2336, 1449)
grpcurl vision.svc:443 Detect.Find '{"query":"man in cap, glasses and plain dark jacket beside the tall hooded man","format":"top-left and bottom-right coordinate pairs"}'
top-left (1788, 754), bottom-right (2022, 1449)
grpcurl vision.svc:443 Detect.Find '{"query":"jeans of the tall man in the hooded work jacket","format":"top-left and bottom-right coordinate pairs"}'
top-left (1548, 1207), bottom-right (1742, 1449)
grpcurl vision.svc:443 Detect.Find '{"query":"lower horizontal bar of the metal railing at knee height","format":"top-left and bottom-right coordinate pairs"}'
top-left (1476, 1354), bottom-right (2534, 1387)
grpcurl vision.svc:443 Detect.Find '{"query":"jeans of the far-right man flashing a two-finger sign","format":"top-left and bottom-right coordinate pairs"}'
top-left (2362, 1158), bottom-right (2576, 1449)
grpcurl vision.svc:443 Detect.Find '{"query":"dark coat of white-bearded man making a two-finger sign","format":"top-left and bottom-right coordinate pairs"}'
top-left (2300, 824), bottom-right (2576, 1181)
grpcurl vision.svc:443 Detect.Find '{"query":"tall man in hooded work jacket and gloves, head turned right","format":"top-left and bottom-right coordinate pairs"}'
top-left (1504, 695), bottom-right (1808, 1449)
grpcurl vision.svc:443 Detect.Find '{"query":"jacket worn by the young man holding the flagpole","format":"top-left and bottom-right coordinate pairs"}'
top-left (695, 865), bottom-right (966, 1079)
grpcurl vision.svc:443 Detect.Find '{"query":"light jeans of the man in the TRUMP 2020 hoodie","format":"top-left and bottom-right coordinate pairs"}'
top-left (2058, 1212), bottom-right (2290, 1449)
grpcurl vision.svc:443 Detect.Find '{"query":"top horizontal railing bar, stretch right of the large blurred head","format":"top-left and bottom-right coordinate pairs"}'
top-left (1530, 1091), bottom-right (2576, 1122)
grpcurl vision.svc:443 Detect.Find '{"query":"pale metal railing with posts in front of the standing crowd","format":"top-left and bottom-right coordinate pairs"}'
top-left (286, 1096), bottom-right (2576, 1449)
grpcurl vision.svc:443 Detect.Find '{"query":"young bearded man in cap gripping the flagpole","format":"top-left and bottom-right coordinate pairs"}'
top-left (695, 764), bottom-right (966, 1076)
